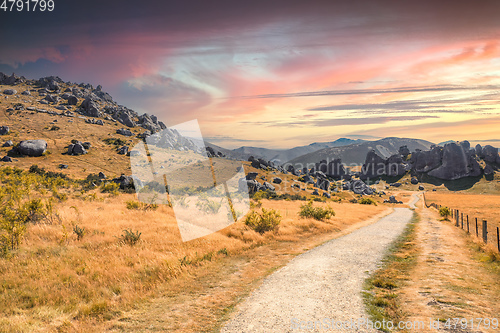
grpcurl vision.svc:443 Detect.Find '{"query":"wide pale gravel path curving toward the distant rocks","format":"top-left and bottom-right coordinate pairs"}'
top-left (221, 208), bottom-right (413, 333)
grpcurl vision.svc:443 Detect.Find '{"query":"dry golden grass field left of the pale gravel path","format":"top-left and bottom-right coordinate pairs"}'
top-left (0, 185), bottom-right (386, 332)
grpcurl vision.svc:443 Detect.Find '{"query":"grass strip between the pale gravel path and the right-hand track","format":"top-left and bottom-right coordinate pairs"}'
top-left (363, 212), bottom-right (419, 332)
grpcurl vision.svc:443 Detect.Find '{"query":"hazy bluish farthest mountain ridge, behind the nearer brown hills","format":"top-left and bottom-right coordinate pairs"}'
top-left (228, 138), bottom-right (364, 164)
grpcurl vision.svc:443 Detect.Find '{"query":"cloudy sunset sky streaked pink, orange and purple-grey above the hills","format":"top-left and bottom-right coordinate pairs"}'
top-left (0, 0), bottom-right (500, 148)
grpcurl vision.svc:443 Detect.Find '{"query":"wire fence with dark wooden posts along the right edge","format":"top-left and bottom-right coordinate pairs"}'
top-left (424, 193), bottom-right (500, 252)
